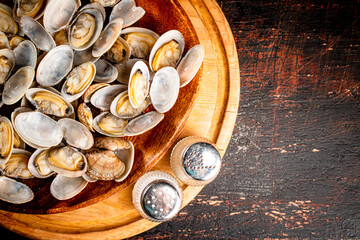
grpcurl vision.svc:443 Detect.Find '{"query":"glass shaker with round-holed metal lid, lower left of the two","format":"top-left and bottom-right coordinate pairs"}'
top-left (133, 171), bottom-right (182, 222)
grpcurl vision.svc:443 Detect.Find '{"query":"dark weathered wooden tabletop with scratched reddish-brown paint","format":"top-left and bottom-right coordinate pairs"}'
top-left (0, 0), bottom-right (360, 239)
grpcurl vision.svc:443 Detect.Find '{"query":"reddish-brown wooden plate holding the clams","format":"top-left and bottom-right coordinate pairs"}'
top-left (0, 0), bottom-right (202, 214)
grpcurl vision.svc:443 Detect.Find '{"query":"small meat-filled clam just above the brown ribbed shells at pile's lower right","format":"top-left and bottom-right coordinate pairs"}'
top-left (93, 112), bottom-right (128, 137)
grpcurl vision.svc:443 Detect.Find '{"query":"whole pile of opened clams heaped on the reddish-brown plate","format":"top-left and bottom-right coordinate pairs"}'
top-left (0, 0), bottom-right (204, 204)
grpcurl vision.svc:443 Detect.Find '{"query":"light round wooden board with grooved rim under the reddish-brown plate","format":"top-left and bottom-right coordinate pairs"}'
top-left (0, 0), bottom-right (240, 239)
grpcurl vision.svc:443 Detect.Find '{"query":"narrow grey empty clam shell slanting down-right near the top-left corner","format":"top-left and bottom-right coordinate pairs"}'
top-left (20, 16), bottom-right (56, 52)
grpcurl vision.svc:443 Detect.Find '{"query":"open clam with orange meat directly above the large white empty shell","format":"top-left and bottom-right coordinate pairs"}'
top-left (25, 88), bottom-right (74, 117)
